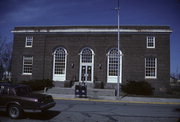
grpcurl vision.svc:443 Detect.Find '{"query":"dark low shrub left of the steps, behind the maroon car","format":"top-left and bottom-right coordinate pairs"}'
top-left (21, 79), bottom-right (54, 91)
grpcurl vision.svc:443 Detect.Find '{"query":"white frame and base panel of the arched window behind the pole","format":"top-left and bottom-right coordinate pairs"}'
top-left (107, 48), bottom-right (122, 83)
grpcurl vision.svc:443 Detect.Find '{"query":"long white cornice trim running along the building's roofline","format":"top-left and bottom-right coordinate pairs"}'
top-left (11, 28), bottom-right (172, 33)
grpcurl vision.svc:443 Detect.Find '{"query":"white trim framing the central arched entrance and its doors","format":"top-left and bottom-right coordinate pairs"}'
top-left (79, 47), bottom-right (95, 82)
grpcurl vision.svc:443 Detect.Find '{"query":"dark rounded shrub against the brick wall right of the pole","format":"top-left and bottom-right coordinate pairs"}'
top-left (121, 81), bottom-right (153, 95)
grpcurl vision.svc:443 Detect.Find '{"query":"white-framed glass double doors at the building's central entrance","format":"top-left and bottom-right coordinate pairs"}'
top-left (81, 65), bottom-right (92, 81)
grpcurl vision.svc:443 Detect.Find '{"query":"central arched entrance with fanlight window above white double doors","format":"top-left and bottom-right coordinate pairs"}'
top-left (79, 47), bottom-right (94, 81)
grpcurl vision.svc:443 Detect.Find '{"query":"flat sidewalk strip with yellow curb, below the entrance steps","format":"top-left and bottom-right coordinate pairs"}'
top-left (46, 93), bottom-right (180, 105)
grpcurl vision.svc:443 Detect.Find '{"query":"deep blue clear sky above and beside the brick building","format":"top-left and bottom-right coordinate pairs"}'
top-left (0, 0), bottom-right (180, 73)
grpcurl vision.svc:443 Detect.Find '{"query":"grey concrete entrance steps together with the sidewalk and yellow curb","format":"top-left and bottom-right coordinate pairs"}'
top-left (41, 87), bottom-right (180, 105)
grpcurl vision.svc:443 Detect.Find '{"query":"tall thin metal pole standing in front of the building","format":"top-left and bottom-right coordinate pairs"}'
top-left (115, 0), bottom-right (120, 97)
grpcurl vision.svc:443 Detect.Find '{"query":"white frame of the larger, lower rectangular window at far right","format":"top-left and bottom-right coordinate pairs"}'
top-left (145, 57), bottom-right (157, 79)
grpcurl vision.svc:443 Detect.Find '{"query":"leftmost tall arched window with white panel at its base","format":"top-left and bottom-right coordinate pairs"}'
top-left (53, 47), bottom-right (67, 81)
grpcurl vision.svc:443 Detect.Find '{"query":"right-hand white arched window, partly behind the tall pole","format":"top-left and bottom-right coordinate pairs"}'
top-left (107, 48), bottom-right (122, 83)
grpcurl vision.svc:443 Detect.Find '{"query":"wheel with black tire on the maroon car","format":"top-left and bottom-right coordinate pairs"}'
top-left (8, 105), bottom-right (23, 119)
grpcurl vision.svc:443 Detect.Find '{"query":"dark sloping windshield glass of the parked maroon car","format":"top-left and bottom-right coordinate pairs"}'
top-left (15, 87), bottom-right (31, 96)
